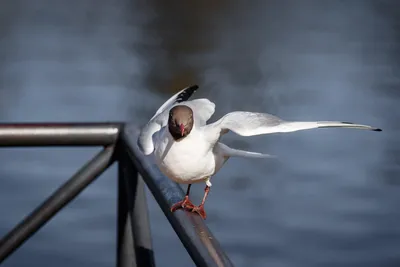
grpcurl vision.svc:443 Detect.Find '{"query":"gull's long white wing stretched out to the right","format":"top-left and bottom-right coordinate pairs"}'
top-left (210, 111), bottom-right (382, 136)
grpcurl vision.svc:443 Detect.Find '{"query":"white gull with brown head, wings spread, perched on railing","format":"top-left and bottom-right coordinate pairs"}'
top-left (137, 85), bottom-right (382, 219)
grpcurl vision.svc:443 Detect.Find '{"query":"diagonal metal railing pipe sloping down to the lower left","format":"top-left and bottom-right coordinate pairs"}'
top-left (0, 146), bottom-right (114, 264)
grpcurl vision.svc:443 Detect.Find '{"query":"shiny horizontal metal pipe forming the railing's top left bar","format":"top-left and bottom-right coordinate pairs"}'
top-left (0, 123), bottom-right (122, 147)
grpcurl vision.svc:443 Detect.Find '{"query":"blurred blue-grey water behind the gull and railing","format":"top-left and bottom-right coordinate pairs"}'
top-left (0, 0), bottom-right (400, 267)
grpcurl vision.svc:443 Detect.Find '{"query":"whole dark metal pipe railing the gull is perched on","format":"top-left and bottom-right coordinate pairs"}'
top-left (0, 123), bottom-right (233, 267)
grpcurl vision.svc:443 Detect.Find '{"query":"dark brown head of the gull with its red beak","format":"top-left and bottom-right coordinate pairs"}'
top-left (168, 105), bottom-right (193, 141)
